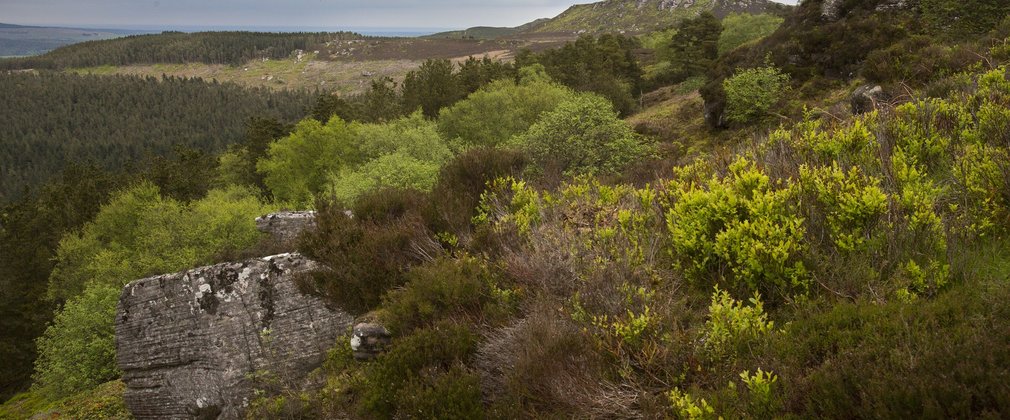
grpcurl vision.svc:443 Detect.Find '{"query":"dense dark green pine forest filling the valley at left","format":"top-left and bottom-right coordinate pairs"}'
top-left (0, 73), bottom-right (314, 203)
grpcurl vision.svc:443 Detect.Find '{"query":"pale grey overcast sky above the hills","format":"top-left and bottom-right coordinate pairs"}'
top-left (0, 0), bottom-right (795, 28)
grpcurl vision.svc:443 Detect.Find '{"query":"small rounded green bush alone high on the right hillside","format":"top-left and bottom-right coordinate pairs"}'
top-left (722, 66), bottom-right (789, 123)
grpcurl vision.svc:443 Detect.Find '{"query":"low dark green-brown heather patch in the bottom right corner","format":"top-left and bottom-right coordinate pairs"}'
top-left (765, 274), bottom-right (1010, 418)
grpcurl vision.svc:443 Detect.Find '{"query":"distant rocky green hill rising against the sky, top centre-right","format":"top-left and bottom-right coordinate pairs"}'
top-left (530, 0), bottom-right (792, 33)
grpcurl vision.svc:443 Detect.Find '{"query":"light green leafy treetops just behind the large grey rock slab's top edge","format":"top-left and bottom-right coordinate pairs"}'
top-left (48, 183), bottom-right (271, 300)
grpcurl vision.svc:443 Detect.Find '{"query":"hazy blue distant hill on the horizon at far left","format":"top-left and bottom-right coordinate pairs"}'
top-left (0, 23), bottom-right (137, 57)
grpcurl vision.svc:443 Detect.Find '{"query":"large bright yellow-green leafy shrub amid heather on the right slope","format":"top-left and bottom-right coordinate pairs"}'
top-left (667, 159), bottom-right (809, 296)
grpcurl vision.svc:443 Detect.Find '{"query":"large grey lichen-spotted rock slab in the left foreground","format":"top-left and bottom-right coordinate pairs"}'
top-left (116, 253), bottom-right (354, 419)
